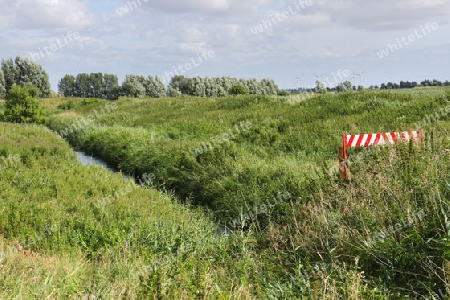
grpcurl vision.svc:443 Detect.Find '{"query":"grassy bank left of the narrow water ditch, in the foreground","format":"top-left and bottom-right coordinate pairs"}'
top-left (0, 123), bottom-right (268, 299)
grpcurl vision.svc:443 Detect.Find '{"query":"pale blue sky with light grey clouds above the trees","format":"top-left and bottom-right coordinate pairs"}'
top-left (0, 0), bottom-right (450, 91)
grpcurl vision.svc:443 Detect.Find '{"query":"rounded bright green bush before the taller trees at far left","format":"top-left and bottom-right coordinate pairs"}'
top-left (5, 85), bottom-right (45, 124)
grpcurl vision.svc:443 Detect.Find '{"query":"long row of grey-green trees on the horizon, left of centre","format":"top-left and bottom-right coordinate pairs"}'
top-left (58, 73), bottom-right (280, 100)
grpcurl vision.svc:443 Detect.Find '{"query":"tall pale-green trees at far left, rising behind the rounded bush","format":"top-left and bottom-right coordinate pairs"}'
top-left (0, 56), bottom-right (50, 98)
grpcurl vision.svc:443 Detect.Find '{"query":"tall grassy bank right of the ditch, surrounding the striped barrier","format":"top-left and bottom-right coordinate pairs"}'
top-left (2, 89), bottom-right (450, 299)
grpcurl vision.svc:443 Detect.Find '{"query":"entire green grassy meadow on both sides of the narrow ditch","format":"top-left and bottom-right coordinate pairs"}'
top-left (0, 88), bottom-right (450, 299)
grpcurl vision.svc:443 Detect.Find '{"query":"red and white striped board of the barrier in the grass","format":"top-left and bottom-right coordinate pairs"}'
top-left (342, 131), bottom-right (421, 148)
